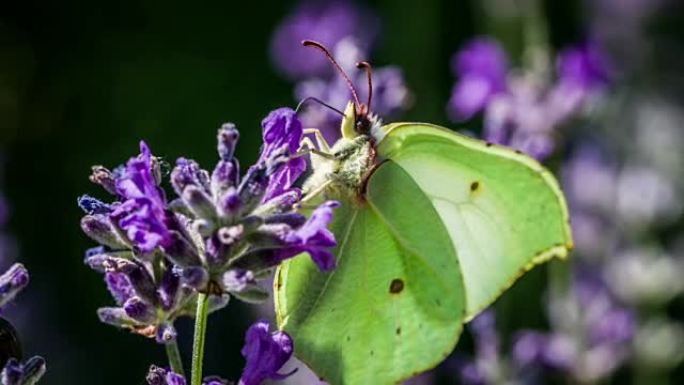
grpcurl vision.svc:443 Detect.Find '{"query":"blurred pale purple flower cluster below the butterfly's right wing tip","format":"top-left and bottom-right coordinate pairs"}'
top-left (513, 268), bottom-right (636, 382)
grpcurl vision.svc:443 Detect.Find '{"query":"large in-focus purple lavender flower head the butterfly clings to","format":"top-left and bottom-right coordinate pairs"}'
top-left (79, 108), bottom-right (337, 343)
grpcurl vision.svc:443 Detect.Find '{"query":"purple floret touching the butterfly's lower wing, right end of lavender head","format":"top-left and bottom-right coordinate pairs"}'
top-left (276, 201), bottom-right (339, 271)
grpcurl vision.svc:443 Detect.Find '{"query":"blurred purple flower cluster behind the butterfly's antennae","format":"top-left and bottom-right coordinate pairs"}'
top-left (272, 0), bottom-right (412, 143)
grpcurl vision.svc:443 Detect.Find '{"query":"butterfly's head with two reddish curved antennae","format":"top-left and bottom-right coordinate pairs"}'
top-left (302, 40), bottom-right (379, 139)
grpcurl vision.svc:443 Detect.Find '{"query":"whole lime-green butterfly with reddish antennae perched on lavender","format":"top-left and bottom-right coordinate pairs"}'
top-left (274, 41), bottom-right (573, 385)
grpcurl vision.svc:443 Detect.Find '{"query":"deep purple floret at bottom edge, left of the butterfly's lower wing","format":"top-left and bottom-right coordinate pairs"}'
top-left (239, 321), bottom-right (296, 385)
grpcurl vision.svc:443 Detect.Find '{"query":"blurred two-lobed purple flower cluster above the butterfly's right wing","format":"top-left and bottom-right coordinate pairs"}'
top-left (447, 37), bottom-right (609, 159)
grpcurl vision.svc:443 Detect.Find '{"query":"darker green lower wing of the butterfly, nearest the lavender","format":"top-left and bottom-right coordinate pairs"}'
top-left (275, 161), bottom-right (465, 385)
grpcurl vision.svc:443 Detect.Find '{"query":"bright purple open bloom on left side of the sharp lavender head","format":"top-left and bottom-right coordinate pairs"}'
top-left (111, 142), bottom-right (174, 252)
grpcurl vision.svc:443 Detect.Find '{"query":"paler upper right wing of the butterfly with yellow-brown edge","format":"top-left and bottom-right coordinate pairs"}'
top-left (378, 123), bottom-right (572, 320)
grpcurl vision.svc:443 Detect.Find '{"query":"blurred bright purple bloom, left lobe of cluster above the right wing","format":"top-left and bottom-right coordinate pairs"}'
top-left (448, 37), bottom-right (508, 121)
